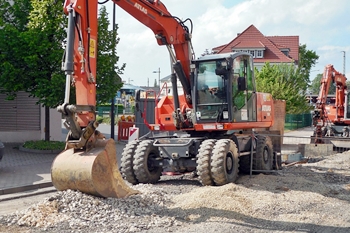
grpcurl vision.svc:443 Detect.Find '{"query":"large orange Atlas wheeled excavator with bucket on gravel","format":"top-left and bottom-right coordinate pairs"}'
top-left (51, 0), bottom-right (282, 197)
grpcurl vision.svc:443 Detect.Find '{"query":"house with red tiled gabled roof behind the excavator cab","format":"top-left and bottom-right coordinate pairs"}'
top-left (212, 25), bottom-right (299, 69)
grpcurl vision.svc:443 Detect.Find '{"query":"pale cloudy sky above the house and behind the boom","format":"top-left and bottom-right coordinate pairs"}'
top-left (102, 0), bottom-right (350, 86)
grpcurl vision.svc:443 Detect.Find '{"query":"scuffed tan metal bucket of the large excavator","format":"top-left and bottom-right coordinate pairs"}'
top-left (51, 139), bottom-right (139, 198)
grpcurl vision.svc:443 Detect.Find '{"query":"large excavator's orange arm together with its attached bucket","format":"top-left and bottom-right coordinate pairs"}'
top-left (51, 0), bottom-right (193, 197)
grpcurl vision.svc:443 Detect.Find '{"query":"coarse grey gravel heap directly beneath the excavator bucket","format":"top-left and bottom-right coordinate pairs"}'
top-left (0, 184), bottom-right (181, 232)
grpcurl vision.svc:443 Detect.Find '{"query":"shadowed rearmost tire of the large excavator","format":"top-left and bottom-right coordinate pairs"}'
top-left (253, 135), bottom-right (273, 171)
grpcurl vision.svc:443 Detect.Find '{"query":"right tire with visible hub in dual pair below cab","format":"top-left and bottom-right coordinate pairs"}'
top-left (210, 139), bottom-right (239, 185)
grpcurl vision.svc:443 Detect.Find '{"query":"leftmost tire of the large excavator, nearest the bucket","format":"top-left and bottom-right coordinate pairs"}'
top-left (120, 140), bottom-right (140, 184)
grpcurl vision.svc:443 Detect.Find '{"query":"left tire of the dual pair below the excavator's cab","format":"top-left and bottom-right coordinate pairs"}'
top-left (196, 139), bottom-right (216, 185)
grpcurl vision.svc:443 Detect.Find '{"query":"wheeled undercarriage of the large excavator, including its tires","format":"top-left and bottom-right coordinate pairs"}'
top-left (121, 132), bottom-right (278, 185)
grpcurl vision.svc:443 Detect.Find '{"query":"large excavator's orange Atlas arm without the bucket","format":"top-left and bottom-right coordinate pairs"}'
top-left (59, 0), bottom-right (194, 140)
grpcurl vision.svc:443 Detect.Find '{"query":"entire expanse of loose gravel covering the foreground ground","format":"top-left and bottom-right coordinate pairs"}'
top-left (0, 152), bottom-right (350, 233)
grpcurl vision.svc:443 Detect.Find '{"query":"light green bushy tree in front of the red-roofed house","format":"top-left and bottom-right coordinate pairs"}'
top-left (255, 62), bottom-right (310, 114)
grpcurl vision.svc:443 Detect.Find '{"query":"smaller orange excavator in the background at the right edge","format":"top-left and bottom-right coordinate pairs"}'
top-left (313, 65), bottom-right (350, 142)
